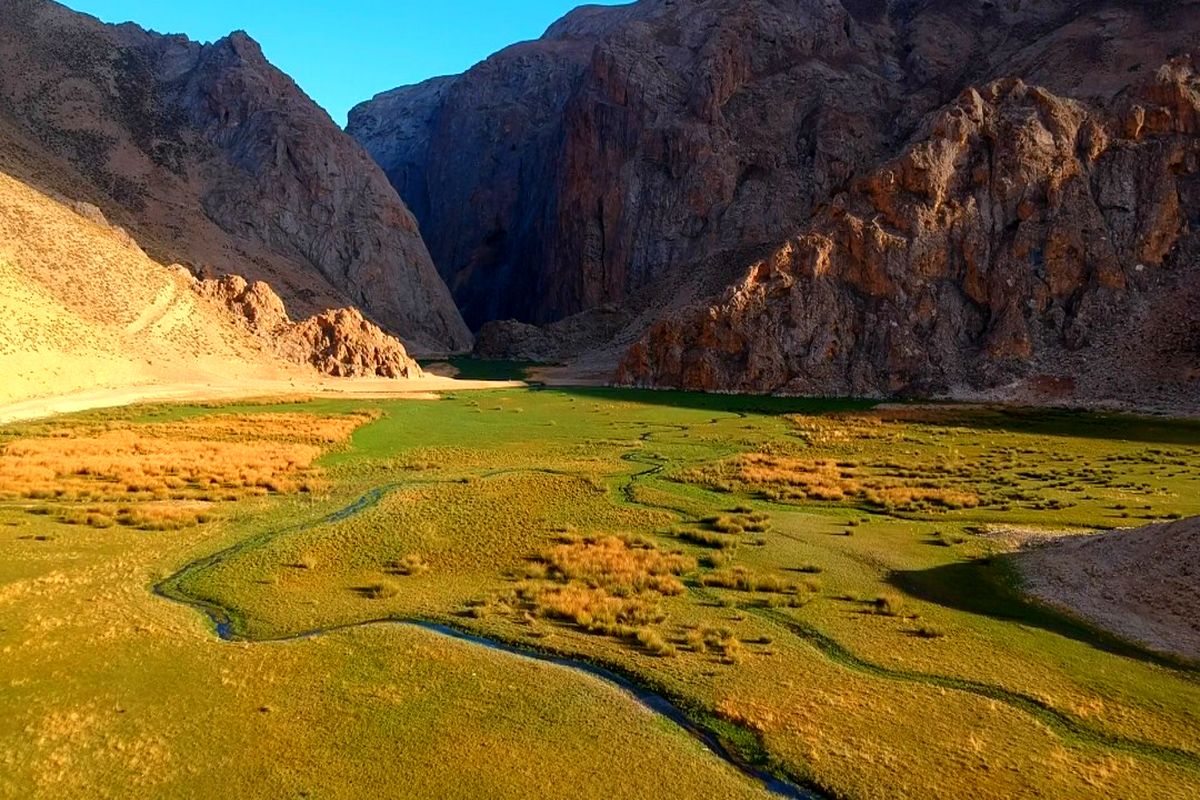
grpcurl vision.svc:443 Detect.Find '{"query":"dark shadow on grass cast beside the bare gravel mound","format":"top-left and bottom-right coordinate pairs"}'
top-left (888, 558), bottom-right (1200, 676)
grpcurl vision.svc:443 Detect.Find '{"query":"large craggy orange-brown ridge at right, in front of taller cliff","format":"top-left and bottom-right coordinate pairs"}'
top-left (618, 58), bottom-right (1200, 404)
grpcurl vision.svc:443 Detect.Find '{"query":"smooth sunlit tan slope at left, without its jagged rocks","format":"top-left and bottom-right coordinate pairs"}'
top-left (0, 174), bottom-right (306, 402)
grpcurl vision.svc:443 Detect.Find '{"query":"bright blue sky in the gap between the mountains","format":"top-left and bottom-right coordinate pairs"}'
top-left (65, 0), bottom-right (624, 125)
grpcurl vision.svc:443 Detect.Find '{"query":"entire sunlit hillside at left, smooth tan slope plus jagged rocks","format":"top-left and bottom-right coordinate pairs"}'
top-left (0, 163), bottom-right (421, 403)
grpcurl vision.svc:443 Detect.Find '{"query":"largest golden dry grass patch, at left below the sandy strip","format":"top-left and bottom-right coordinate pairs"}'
top-left (0, 414), bottom-right (374, 530)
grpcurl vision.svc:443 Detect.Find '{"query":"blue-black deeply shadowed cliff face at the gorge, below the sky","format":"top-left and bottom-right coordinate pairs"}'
top-left (349, 43), bottom-right (597, 327)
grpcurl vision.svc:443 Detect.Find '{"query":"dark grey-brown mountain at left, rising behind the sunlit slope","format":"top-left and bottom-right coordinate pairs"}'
top-left (0, 0), bottom-right (470, 351)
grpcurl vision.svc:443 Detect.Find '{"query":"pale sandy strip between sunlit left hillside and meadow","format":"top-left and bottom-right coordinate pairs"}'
top-left (0, 375), bottom-right (526, 425)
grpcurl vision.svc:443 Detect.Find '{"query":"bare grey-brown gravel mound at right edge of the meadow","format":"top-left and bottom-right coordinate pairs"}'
top-left (1016, 517), bottom-right (1200, 662)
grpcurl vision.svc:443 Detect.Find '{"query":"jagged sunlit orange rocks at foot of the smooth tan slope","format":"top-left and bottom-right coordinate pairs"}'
top-left (192, 275), bottom-right (422, 378)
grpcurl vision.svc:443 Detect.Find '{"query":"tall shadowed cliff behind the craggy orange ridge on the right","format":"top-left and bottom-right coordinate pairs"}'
top-left (349, 0), bottom-right (1198, 327)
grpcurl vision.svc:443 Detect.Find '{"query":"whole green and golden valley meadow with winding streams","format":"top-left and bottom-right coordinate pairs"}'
top-left (0, 389), bottom-right (1200, 799)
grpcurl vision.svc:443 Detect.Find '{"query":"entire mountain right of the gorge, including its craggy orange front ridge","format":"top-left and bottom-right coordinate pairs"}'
top-left (349, 0), bottom-right (1200, 410)
